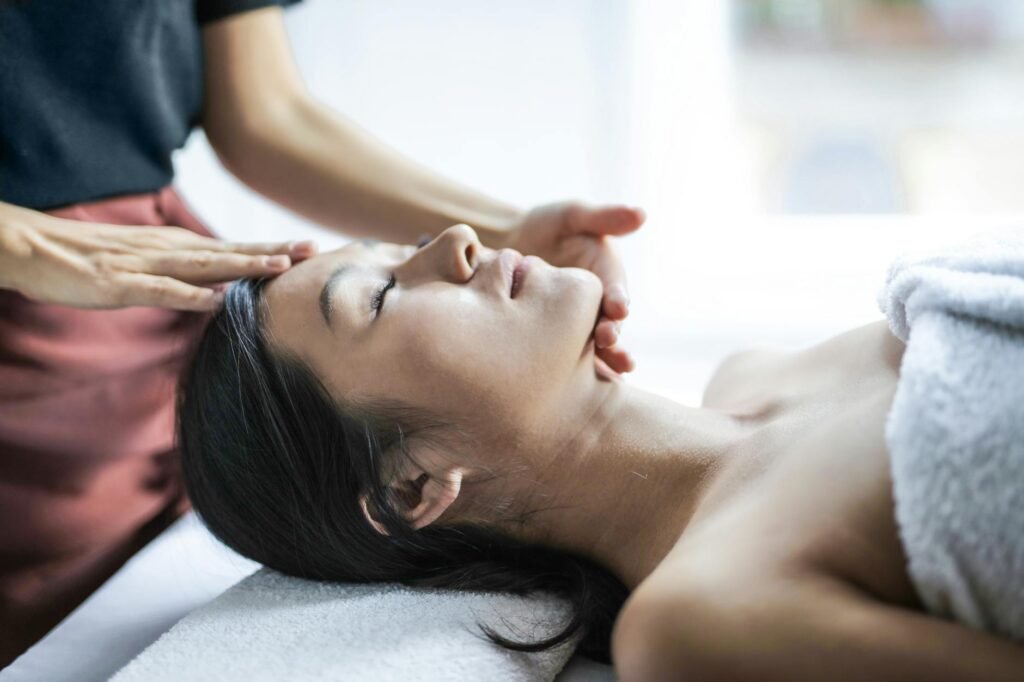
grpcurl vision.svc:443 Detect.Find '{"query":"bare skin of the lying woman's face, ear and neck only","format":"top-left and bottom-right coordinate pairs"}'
top-left (260, 225), bottom-right (748, 587)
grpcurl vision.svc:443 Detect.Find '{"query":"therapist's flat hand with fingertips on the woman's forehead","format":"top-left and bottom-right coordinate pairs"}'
top-left (0, 212), bottom-right (316, 310)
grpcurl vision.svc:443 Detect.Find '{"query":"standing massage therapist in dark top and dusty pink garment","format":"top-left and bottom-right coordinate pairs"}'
top-left (0, 0), bottom-right (644, 667)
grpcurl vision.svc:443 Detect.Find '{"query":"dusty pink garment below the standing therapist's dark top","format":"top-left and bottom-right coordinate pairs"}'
top-left (0, 186), bottom-right (211, 667)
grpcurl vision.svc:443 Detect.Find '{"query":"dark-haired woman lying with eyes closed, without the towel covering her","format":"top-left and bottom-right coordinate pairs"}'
top-left (179, 225), bottom-right (1024, 682)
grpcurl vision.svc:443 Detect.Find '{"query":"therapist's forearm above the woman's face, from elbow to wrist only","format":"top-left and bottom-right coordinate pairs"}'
top-left (204, 97), bottom-right (522, 247)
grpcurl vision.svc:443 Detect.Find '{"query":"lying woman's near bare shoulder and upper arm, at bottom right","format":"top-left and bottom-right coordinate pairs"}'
top-left (612, 552), bottom-right (1024, 682)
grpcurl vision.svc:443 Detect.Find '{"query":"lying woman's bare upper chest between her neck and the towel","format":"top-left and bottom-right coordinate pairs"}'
top-left (670, 326), bottom-right (920, 607)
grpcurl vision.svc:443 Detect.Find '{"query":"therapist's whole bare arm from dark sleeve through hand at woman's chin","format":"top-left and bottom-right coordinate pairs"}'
top-left (202, 7), bottom-right (645, 379)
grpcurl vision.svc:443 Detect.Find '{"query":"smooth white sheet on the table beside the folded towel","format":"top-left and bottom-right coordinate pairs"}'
top-left (0, 514), bottom-right (615, 682)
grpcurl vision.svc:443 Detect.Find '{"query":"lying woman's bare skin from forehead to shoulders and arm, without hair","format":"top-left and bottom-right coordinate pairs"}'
top-left (266, 231), bottom-right (1024, 682)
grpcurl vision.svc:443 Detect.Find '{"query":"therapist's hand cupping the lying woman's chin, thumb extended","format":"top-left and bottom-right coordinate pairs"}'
top-left (509, 202), bottom-right (646, 375)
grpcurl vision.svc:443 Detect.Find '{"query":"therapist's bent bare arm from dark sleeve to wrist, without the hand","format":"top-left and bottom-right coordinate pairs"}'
top-left (202, 7), bottom-right (525, 247)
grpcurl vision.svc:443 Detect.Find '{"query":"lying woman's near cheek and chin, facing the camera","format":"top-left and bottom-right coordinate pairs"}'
top-left (364, 270), bottom-right (602, 424)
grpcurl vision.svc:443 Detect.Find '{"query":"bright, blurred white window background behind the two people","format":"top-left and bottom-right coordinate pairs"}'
top-left (176, 0), bottom-right (1024, 404)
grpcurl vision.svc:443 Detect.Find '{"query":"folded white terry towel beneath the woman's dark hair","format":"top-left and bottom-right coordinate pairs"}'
top-left (112, 568), bottom-right (577, 682)
